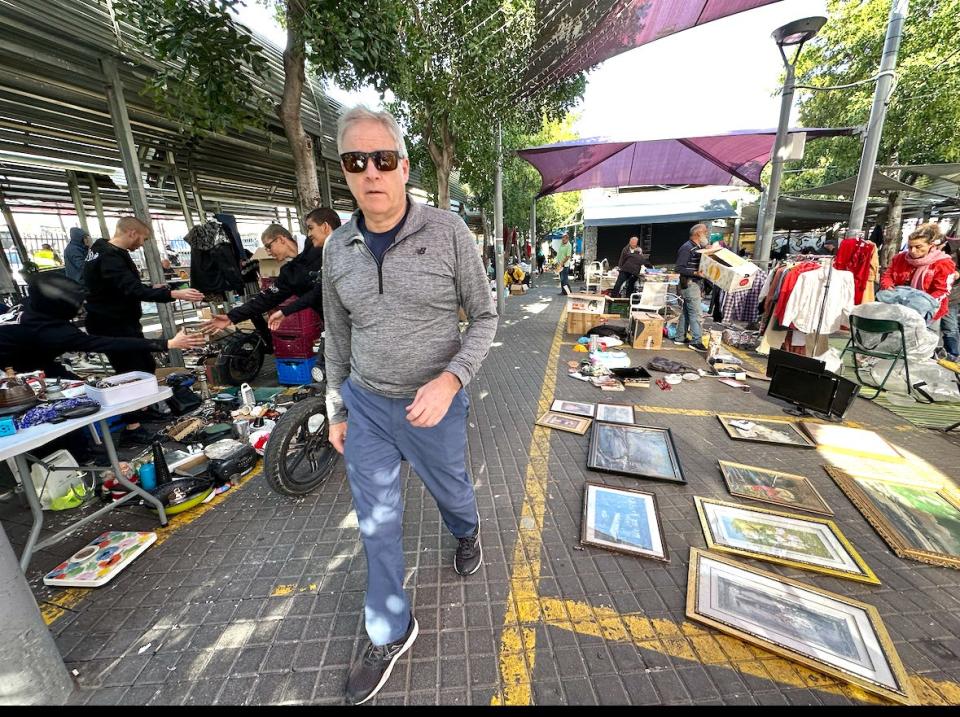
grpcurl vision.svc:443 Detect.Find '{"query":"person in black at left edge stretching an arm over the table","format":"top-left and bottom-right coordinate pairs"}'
top-left (0, 272), bottom-right (204, 378)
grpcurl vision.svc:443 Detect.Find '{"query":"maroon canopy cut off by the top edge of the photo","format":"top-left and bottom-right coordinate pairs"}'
top-left (519, 0), bottom-right (778, 95)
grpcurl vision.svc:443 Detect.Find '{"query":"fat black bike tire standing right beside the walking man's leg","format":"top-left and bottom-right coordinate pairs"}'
top-left (263, 396), bottom-right (340, 496)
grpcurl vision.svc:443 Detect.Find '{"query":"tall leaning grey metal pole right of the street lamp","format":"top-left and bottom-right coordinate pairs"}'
top-left (847, 0), bottom-right (910, 230)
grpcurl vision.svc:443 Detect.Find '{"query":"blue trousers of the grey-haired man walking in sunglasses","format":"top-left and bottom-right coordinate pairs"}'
top-left (341, 379), bottom-right (478, 645)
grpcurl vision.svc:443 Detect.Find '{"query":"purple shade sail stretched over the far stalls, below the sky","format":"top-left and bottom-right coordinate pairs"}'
top-left (517, 128), bottom-right (853, 197)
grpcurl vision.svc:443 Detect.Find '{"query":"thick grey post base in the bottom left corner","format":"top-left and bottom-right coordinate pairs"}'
top-left (0, 516), bottom-right (74, 705)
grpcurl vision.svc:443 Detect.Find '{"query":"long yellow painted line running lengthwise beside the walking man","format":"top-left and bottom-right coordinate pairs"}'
top-left (491, 309), bottom-right (566, 705)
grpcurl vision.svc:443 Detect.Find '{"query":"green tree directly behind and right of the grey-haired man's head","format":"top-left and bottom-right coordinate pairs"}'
top-left (389, 0), bottom-right (585, 209)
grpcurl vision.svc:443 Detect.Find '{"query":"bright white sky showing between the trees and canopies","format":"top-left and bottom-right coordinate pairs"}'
top-left (231, 0), bottom-right (827, 139)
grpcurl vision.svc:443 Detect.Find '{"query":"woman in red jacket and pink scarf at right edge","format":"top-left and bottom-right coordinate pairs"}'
top-left (880, 222), bottom-right (957, 322)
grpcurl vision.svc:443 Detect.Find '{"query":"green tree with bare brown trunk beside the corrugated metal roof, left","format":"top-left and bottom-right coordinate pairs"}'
top-left (114, 0), bottom-right (406, 217)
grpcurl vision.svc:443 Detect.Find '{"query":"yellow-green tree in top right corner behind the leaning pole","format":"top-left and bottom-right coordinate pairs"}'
top-left (784, 0), bottom-right (960, 263)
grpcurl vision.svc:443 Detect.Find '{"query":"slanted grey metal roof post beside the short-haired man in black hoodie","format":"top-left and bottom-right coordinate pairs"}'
top-left (100, 57), bottom-right (184, 366)
